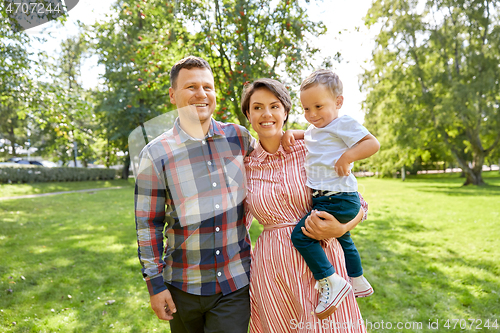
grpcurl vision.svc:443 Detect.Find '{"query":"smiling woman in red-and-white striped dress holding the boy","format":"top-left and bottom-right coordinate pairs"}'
top-left (241, 79), bottom-right (367, 333)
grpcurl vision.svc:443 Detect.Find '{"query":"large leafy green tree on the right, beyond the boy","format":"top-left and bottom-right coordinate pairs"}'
top-left (363, 0), bottom-right (500, 185)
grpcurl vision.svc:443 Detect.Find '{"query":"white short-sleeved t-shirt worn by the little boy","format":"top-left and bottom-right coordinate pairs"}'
top-left (304, 115), bottom-right (370, 192)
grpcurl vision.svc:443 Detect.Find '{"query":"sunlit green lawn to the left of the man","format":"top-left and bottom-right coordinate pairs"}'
top-left (0, 182), bottom-right (168, 332)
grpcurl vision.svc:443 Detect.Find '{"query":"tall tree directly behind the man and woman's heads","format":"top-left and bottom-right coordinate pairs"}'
top-left (93, 0), bottom-right (325, 177)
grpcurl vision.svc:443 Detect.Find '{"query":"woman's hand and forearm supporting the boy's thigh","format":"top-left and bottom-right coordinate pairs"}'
top-left (302, 209), bottom-right (364, 240)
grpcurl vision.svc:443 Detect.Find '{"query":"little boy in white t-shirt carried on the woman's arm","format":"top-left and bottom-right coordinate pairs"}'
top-left (283, 70), bottom-right (380, 319)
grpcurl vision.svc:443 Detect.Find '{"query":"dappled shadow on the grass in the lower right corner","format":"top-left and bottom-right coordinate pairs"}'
top-left (353, 215), bottom-right (500, 332)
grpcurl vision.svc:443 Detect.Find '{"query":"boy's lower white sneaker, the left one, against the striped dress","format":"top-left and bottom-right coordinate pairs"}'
top-left (314, 273), bottom-right (352, 320)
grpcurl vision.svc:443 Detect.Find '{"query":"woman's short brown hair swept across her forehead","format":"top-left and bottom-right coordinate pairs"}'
top-left (241, 79), bottom-right (292, 124)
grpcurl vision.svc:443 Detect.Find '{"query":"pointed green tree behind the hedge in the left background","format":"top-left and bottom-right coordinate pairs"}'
top-left (27, 36), bottom-right (97, 166)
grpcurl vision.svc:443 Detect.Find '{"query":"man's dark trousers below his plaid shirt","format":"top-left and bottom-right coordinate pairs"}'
top-left (167, 284), bottom-right (250, 333)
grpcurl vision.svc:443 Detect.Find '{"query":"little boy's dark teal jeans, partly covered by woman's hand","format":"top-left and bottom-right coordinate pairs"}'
top-left (292, 192), bottom-right (363, 280)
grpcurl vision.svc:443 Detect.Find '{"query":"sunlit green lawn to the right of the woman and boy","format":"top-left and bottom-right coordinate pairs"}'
top-left (353, 172), bottom-right (500, 332)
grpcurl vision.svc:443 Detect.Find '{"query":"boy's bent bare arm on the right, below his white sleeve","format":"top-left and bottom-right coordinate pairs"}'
top-left (335, 134), bottom-right (380, 177)
